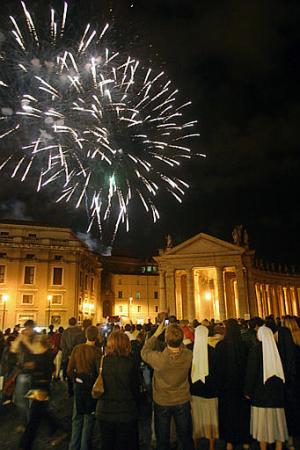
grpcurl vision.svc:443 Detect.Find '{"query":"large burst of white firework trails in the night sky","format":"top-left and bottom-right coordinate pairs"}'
top-left (0, 2), bottom-right (204, 250)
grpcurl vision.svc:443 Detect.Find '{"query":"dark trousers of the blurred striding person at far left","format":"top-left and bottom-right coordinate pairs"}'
top-left (20, 400), bottom-right (62, 450)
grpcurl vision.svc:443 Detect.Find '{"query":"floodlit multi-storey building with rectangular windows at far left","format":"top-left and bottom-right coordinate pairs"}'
top-left (0, 222), bottom-right (102, 329)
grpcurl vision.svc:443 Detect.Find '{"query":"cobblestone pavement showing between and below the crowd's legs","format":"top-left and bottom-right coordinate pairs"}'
top-left (0, 382), bottom-right (300, 450)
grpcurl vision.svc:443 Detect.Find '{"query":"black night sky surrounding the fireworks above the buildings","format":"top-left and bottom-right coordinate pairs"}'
top-left (0, 0), bottom-right (300, 264)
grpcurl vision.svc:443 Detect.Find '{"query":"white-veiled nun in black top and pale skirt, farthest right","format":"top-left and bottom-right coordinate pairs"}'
top-left (245, 325), bottom-right (288, 450)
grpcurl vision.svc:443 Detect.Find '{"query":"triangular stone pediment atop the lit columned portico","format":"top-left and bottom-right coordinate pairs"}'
top-left (162, 233), bottom-right (245, 257)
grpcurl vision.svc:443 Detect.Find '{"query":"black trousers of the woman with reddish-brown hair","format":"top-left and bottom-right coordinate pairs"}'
top-left (100, 420), bottom-right (139, 450)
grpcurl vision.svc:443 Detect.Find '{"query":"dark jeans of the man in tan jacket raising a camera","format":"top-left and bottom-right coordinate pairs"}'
top-left (154, 402), bottom-right (195, 450)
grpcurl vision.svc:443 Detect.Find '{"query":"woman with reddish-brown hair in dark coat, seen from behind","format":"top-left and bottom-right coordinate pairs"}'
top-left (96, 331), bottom-right (139, 450)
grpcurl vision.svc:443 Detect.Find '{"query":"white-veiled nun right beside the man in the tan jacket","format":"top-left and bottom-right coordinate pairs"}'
top-left (191, 325), bottom-right (219, 450)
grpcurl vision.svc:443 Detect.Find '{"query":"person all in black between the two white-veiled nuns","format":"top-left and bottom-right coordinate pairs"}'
top-left (216, 319), bottom-right (250, 450)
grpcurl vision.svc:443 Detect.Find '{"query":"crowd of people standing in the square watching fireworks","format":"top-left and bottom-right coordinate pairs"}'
top-left (0, 313), bottom-right (300, 450)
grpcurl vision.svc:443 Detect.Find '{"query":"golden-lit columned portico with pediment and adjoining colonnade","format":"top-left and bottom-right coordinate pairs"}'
top-left (154, 233), bottom-right (300, 320)
